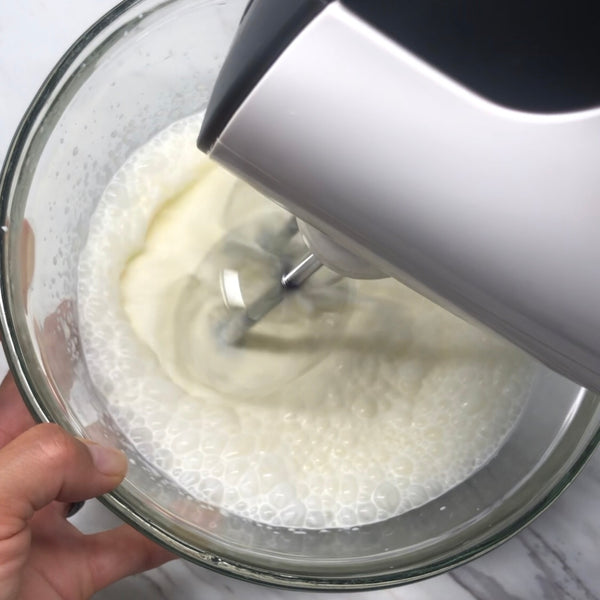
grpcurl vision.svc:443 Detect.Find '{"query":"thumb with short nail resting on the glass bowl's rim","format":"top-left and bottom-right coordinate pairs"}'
top-left (0, 424), bottom-right (127, 539)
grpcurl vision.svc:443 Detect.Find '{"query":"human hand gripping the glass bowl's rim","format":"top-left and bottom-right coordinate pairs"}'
top-left (0, 375), bottom-right (175, 600)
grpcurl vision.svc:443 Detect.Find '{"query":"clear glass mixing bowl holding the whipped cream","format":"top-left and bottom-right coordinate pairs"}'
top-left (0, 0), bottom-right (600, 590)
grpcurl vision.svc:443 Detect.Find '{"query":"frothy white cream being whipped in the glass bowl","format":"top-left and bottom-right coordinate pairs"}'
top-left (79, 117), bottom-right (535, 528)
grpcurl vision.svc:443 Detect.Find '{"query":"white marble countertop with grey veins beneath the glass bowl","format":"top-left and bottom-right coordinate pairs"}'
top-left (0, 0), bottom-right (600, 600)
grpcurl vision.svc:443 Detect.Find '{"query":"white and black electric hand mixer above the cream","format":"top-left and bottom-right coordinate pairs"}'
top-left (198, 0), bottom-right (600, 391)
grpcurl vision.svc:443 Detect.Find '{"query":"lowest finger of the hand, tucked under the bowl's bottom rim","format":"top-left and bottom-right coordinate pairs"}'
top-left (86, 525), bottom-right (177, 592)
